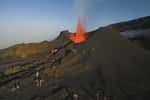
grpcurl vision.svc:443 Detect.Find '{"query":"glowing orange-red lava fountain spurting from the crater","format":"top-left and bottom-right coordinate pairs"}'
top-left (68, 17), bottom-right (88, 44)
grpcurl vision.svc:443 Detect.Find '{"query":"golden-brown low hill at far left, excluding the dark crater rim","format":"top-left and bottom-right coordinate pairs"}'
top-left (0, 41), bottom-right (51, 59)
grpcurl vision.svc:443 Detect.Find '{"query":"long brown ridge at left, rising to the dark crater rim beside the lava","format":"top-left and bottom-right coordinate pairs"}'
top-left (0, 31), bottom-right (70, 60)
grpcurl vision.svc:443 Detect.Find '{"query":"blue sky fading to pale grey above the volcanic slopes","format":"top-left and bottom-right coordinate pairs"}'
top-left (0, 0), bottom-right (150, 49)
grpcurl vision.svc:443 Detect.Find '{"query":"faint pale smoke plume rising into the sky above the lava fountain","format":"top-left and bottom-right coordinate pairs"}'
top-left (74, 0), bottom-right (103, 30)
